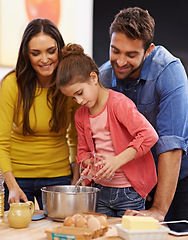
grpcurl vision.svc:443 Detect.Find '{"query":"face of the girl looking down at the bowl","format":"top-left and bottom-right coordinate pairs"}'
top-left (60, 76), bottom-right (99, 108)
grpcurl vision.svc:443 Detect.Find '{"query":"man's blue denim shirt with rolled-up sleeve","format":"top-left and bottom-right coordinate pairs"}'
top-left (99, 46), bottom-right (188, 179)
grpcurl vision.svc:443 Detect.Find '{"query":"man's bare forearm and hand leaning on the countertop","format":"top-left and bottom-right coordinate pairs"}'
top-left (125, 149), bottom-right (182, 221)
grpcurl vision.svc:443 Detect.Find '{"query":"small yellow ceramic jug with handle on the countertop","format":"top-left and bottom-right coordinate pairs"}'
top-left (7, 201), bottom-right (34, 228)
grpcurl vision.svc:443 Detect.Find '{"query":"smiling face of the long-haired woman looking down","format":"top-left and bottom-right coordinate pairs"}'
top-left (28, 33), bottom-right (58, 81)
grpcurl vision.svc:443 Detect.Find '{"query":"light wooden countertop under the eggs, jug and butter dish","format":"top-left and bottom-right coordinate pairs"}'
top-left (0, 211), bottom-right (188, 240)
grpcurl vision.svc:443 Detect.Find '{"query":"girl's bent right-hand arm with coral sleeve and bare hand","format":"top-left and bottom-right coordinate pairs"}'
top-left (97, 96), bottom-right (158, 179)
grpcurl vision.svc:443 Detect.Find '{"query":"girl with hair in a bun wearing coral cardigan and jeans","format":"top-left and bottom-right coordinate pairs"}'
top-left (56, 44), bottom-right (158, 217)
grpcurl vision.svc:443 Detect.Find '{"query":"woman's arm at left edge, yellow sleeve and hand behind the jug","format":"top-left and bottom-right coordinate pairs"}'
top-left (0, 73), bottom-right (27, 203)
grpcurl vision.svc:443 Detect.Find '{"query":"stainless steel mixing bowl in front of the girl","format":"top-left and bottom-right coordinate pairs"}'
top-left (41, 185), bottom-right (100, 221)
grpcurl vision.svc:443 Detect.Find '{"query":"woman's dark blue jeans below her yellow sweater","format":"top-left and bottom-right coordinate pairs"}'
top-left (5, 175), bottom-right (71, 210)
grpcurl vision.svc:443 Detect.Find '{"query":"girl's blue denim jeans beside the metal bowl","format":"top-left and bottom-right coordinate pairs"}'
top-left (93, 183), bottom-right (145, 217)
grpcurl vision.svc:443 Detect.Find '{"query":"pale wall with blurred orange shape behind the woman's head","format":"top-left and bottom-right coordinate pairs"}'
top-left (0, 0), bottom-right (93, 79)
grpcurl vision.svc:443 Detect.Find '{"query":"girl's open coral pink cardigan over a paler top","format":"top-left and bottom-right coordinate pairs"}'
top-left (75, 90), bottom-right (158, 198)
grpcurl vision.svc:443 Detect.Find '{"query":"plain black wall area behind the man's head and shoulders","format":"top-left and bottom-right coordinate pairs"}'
top-left (93, 0), bottom-right (188, 73)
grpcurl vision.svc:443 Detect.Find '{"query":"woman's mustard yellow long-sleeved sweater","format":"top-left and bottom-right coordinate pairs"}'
top-left (0, 73), bottom-right (78, 178)
